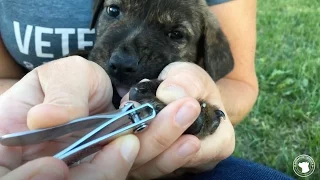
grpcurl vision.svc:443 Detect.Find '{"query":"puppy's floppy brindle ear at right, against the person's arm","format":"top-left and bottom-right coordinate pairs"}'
top-left (200, 11), bottom-right (234, 81)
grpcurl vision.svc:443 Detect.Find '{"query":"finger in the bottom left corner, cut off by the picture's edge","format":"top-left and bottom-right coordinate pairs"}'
top-left (0, 158), bottom-right (68, 180)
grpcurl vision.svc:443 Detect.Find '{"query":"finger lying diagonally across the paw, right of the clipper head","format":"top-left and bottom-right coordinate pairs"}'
top-left (129, 98), bottom-right (200, 169)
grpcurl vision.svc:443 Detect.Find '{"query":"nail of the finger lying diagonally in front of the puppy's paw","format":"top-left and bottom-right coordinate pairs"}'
top-left (176, 102), bottom-right (198, 127)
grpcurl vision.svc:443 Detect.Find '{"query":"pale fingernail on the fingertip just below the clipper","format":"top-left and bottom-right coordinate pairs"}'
top-left (121, 137), bottom-right (138, 162)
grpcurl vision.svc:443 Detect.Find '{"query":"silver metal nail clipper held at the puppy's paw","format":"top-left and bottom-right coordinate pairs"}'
top-left (0, 102), bottom-right (156, 165)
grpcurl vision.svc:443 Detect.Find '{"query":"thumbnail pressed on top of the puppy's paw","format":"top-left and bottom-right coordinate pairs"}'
top-left (160, 85), bottom-right (187, 103)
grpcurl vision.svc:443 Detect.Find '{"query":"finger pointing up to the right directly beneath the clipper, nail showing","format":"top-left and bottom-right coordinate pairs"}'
top-left (69, 135), bottom-right (140, 180)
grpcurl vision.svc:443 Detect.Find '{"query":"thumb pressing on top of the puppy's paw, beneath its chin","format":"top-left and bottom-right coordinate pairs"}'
top-left (157, 62), bottom-right (220, 104)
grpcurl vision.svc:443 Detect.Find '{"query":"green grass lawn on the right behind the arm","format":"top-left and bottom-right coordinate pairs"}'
top-left (234, 0), bottom-right (320, 180)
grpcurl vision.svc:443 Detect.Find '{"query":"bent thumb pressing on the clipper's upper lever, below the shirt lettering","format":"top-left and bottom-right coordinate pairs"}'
top-left (27, 56), bottom-right (112, 129)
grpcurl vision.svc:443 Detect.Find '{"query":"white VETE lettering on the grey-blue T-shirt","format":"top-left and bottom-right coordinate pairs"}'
top-left (13, 21), bottom-right (95, 59)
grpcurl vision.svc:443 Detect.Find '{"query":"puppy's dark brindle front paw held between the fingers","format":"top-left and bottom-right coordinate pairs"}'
top-left (129, 80), bottom-right (224, 139)
